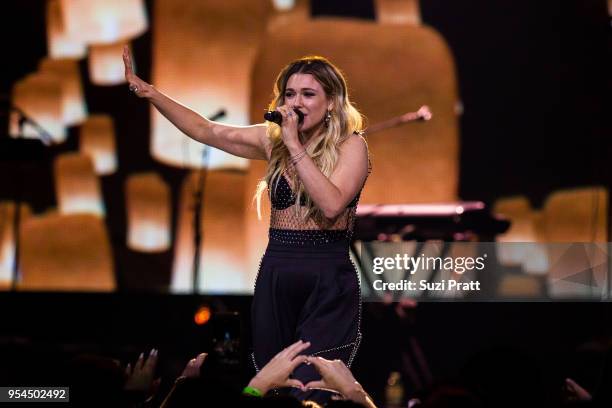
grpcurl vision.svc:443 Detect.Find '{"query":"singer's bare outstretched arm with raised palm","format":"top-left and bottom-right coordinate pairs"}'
top-left (123, 46), bottom-right (271, 160)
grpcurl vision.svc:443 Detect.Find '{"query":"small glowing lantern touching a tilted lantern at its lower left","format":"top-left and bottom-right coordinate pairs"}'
top-left (79, 114), bottom-right (117, 176)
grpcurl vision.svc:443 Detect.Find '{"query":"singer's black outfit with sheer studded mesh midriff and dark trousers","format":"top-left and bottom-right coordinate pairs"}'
top-left (252, 167), bottom-right (361, 402)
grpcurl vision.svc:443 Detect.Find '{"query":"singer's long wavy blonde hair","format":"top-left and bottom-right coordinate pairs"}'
top-left (255, 56), bottom-right (364, 220)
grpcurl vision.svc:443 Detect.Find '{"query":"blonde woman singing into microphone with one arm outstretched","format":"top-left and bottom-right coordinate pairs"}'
top-left (124, 48), bottom-right (369, 398)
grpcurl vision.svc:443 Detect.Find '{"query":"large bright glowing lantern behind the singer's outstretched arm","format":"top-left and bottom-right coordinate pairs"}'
top-left (150, 0), bottom-right (272, 169)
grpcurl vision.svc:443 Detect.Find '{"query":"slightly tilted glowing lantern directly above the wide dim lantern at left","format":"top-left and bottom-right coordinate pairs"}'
top-left (54, 153), bottom-right (105, 217)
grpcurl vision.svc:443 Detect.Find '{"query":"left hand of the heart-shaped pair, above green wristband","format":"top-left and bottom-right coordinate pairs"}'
top-left (249, 340), bottom-right (310, 394)
